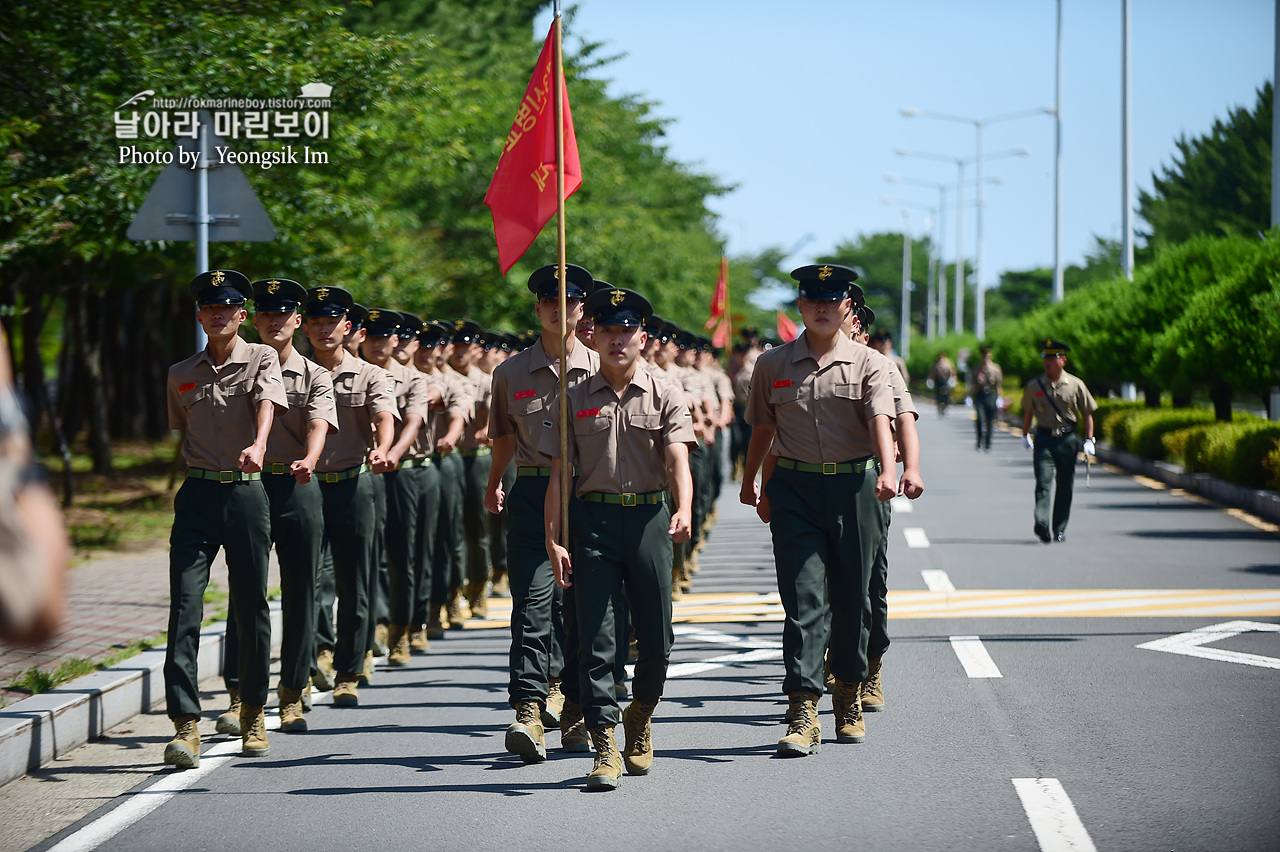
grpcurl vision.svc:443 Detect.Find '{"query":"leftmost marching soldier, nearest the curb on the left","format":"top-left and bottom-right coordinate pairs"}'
top-left (164, 269), bottom-right (288, 769)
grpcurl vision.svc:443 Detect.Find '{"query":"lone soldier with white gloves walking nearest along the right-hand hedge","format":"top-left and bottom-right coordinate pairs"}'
top-left (1023, 339), bottom-right (1098, 544)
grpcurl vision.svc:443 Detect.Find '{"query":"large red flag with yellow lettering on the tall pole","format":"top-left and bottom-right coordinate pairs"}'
top-left (484, 22), bottom-right (582, 275)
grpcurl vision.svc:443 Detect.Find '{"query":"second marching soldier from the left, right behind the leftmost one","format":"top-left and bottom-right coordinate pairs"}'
top-left (218, 278), bottom-right (338, 734)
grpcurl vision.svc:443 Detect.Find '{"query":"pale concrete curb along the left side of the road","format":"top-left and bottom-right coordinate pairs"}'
top-left (0, 601), bottom-right (282, 785)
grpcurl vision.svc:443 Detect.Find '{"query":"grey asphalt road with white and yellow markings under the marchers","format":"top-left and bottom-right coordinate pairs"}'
top-left (0, 408), bottom-right (1280, 852)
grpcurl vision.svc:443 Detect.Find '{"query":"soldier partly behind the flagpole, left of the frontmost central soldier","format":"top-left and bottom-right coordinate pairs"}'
top-left (485, 264), bottom-right (600, 764)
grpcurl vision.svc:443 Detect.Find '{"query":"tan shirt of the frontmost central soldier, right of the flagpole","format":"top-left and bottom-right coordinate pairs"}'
top-left (539, 365), bottom-right (695, 496)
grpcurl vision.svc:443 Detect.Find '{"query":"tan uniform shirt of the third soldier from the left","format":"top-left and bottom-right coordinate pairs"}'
top-left (316, 352), bottom-right (399, 473)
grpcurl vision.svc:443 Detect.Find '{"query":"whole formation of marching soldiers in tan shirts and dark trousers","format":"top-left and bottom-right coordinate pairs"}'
top-left (164, 265), bottom-right (924, 789)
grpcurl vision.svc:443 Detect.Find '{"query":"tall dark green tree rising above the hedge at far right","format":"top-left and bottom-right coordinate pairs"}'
top-left (1138, 82), bottom-right (1275, 249)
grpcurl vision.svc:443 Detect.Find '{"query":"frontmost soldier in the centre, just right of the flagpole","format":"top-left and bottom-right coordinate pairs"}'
top-left (540, 289), bottom-right (694, 789)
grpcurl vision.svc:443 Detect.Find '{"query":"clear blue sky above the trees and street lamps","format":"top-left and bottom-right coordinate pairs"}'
top-left (535, 0), bottom-right (1276, 287)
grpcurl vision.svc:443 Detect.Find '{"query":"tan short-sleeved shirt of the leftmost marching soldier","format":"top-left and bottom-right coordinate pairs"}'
top-left (165, 338), bottom-right (289, 471)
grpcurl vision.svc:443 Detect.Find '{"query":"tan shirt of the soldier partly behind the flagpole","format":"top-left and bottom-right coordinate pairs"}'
top-left (489, 338), bottom-right (600, 467)
